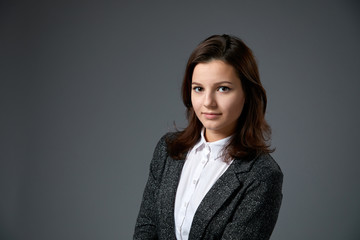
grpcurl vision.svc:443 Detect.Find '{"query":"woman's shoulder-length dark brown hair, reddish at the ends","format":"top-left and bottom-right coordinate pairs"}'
top-left (167, 34), bottom-right (273, 161)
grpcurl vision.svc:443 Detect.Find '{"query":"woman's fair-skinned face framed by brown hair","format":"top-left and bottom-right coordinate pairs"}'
top-left (191, 60), bottom-right (245, 142)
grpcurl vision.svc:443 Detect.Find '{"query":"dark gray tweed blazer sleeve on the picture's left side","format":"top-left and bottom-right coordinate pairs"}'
top-left (133, 135), bottom-right (167, 240)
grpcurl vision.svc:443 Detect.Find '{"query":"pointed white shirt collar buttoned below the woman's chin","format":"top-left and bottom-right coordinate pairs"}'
top-left (194, 128), bottom-right (231, 160)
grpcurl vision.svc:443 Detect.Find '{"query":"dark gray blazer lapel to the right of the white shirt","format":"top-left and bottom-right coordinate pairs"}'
top-left (189, 159), bottom-right (253, 239)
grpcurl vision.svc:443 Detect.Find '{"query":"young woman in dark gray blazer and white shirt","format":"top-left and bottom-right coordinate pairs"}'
top-left (134, 35), bottom-right (283, 240)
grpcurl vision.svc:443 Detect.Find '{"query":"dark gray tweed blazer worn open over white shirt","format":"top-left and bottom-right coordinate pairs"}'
top-left (134, 134), bottom-right (283, 240)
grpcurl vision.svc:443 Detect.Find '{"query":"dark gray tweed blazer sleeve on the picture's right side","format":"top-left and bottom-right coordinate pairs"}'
top-left (221, 167), bottom-right (283, 240)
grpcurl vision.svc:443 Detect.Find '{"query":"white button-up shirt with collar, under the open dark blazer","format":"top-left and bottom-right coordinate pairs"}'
top-left (174, 130), bottom-right (232, 240)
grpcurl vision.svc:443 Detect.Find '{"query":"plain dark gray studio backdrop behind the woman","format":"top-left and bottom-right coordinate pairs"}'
top-left (0, 0), bottom-right (360, 240)
